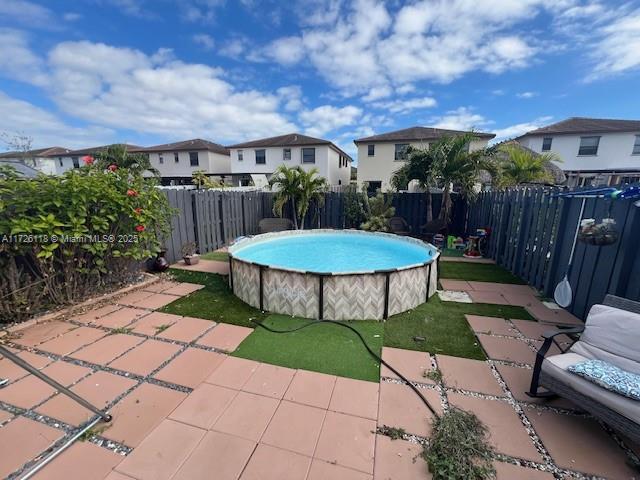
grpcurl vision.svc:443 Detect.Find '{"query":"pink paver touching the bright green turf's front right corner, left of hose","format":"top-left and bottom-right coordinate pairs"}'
top-left (329, 377), bottom-right (380, 420)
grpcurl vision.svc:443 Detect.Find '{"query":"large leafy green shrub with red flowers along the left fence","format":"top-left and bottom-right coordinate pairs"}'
top-left (0, 157), bottom-right (171, 322)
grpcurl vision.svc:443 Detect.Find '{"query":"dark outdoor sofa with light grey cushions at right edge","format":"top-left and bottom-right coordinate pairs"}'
top-left (527, 295), bottom-right (640, 442)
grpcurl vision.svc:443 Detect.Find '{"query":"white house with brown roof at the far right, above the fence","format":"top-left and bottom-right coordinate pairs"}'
top-left (516, 117), bottom-right (640, 186)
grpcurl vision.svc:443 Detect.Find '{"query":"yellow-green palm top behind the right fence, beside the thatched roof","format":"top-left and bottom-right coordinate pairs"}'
top-left (498, 144), bottom-right (560, 187)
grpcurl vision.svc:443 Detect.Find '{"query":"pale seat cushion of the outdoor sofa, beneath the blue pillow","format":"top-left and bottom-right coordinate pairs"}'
top-left (542, 353), bottom-right (640, 424)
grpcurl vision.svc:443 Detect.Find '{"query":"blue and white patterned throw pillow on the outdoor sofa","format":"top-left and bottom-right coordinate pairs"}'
top-left (567, 360), bottom-right (640, 400)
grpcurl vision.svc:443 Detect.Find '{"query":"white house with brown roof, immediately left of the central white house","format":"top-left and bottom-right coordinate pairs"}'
top-left (139, 138), bottom-right (232, 185)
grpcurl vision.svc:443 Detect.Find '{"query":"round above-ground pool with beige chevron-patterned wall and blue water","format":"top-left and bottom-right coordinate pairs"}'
top-left (229, 230), bottom-right (439, 320)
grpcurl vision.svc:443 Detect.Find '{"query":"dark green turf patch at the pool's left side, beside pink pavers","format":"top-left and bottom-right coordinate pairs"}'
top-left (160, 268), bottom-right (266, 328)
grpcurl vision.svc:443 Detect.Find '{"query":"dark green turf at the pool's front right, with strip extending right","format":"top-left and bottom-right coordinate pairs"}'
top-left (384, 295), bottom-right (533, 360)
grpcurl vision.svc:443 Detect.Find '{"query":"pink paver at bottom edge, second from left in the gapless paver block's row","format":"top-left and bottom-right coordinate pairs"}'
top-left (173, 432), bottom-right (256, 480)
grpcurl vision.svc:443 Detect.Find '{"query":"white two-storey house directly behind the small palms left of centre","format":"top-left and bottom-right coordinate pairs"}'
top-left (229, 133), bottom-right (353, 186)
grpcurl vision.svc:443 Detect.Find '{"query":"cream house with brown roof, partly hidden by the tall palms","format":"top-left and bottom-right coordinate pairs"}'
top-left (354, 127), bottom-right (495, 191)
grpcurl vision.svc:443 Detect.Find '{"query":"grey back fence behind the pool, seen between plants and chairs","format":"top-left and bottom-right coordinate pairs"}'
top-left (163, 189), bottom-right (466, 262)
